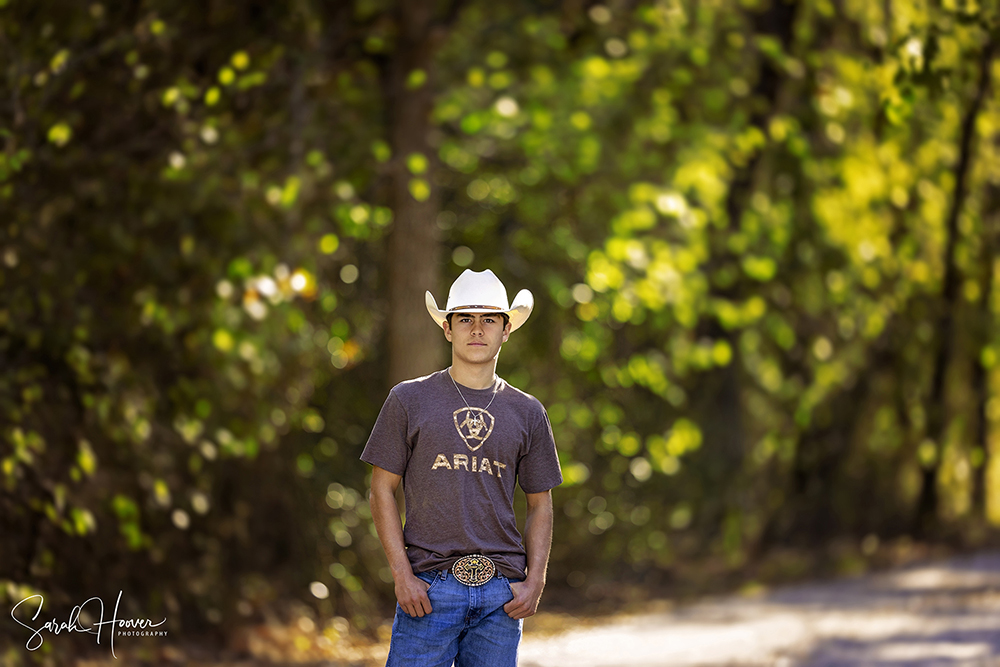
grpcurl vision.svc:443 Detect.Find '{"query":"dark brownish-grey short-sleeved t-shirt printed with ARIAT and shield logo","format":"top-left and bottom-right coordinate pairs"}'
top-left (361, 369), bottom-right (562, 579)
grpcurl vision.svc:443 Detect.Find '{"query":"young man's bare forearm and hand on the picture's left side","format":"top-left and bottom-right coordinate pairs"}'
top-left (369, 466), bottom-right (431, 617)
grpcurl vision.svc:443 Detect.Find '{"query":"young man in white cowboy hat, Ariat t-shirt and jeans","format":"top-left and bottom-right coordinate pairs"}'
top-left (361, 270), bottom-right (562, 667)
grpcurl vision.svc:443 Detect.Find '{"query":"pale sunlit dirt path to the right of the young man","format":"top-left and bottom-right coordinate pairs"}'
top-left (519, 553), bottom-right (1000, 667)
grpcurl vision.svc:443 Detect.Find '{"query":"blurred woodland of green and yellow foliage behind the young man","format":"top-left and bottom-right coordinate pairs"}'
top-left (0, 0), bottom-right (1000, 665)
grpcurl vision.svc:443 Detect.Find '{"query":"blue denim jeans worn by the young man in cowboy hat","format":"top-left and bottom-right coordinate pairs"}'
top-left (386, 570), bottom-right (521, 667)
